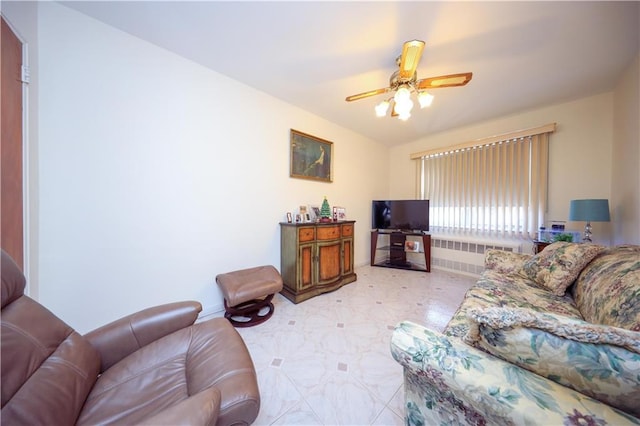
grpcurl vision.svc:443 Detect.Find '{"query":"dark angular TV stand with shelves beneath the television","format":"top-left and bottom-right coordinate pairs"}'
top-left (371, 229), bottom-right (431, 272)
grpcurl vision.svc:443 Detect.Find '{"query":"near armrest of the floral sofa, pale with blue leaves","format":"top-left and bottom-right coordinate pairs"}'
top-left (391, 322), bottom-right (638, 424)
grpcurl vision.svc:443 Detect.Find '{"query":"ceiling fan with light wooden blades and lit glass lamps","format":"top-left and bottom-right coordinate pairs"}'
top-left (346, 40), bottom-right (473, 120)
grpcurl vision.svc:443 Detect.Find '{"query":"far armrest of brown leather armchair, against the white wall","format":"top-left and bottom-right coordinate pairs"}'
top-left (84, 301), bottom-right (202, 372)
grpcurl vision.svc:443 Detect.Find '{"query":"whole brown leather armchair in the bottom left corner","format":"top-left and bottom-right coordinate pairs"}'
top-left (0, 250), bottom-right (260, 425)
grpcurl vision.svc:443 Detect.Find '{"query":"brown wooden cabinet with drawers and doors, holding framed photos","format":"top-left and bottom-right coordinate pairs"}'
top-left (280, 221), bottom-right (357, 303)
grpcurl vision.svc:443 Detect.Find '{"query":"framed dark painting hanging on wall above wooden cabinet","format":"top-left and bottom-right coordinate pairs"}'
top-left (289, 129), bottom-right (333, 182)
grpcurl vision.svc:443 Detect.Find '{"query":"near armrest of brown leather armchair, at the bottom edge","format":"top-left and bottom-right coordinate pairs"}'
top-left (137, 388), bottom-right (221, 426)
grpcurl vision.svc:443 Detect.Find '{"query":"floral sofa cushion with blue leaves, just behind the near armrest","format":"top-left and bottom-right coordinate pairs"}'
top-left (464, 307), bottom-right (640, 416)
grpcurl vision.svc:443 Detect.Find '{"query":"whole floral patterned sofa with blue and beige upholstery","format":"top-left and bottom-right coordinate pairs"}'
top-left (391, 242), bottom-right (640, 426)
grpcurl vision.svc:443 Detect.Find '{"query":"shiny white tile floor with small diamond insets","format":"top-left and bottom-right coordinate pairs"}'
top-left (232, 266), bottom-right (476, 425)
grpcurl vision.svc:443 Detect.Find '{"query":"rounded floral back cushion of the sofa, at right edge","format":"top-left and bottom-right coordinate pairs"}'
top-left (573, 245), bottom-right (640, 331)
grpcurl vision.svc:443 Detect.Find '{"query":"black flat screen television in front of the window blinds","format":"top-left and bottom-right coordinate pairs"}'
top-left (371, 200), bottom-right (429, 232)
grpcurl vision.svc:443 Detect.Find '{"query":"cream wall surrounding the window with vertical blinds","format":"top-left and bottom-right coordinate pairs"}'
top-left (390, 93), bottom-right (616, 244)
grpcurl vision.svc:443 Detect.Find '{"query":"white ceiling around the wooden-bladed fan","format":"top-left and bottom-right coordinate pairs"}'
top-left (62, 1), bottom-right (640, 146)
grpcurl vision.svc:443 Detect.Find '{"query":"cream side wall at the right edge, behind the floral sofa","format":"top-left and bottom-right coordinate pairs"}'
top-left (611, 56), bottom-right (640, 244)
